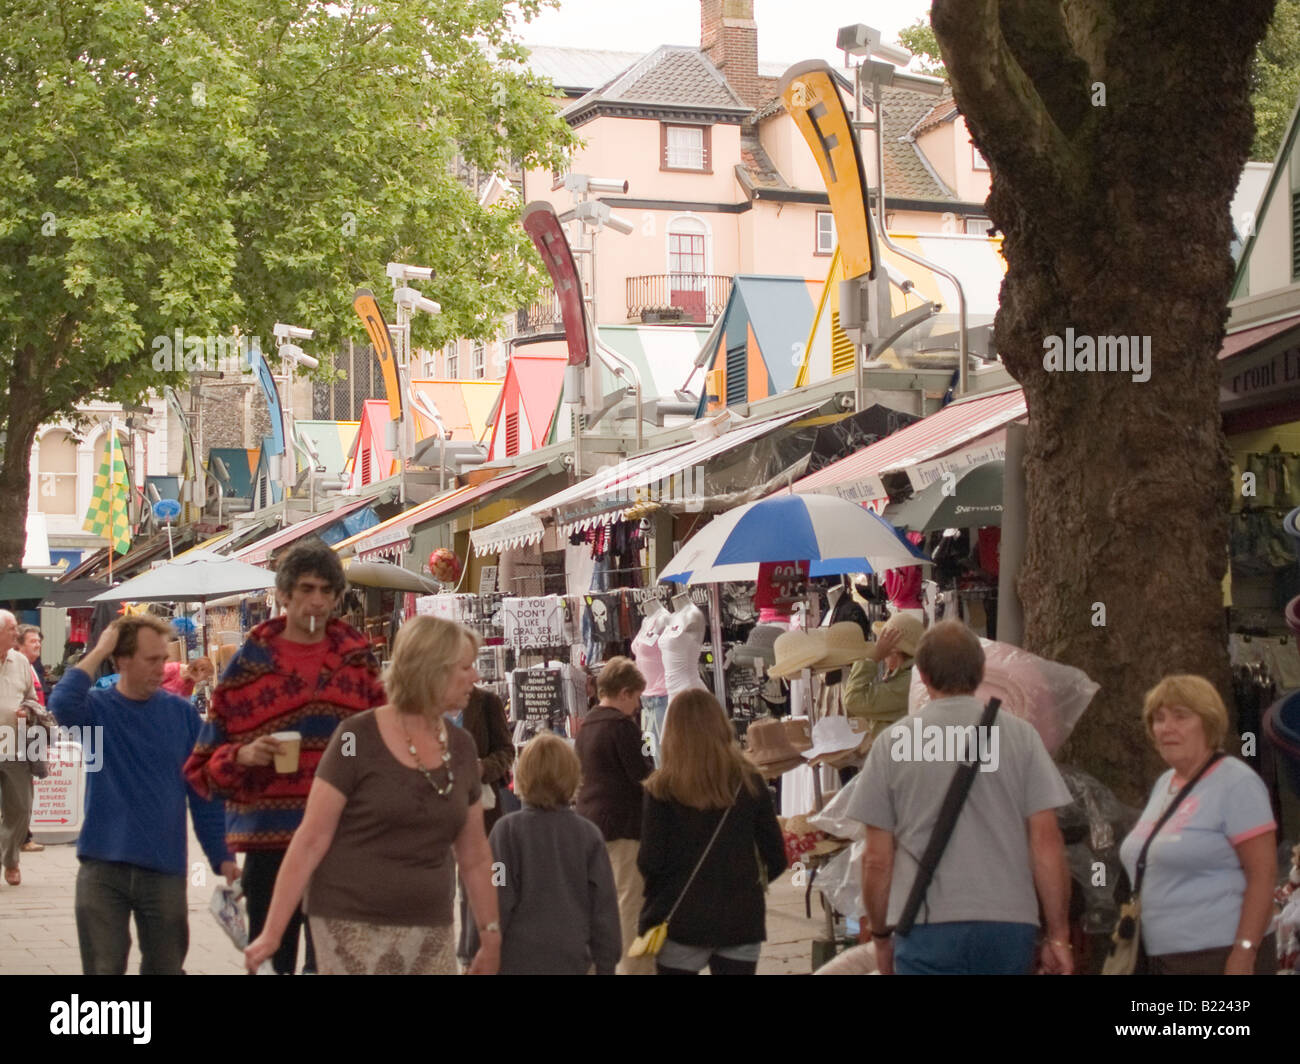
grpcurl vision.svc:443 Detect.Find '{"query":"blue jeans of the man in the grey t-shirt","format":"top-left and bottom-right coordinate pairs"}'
top-left (894, 920), bottom-right (1039, 976)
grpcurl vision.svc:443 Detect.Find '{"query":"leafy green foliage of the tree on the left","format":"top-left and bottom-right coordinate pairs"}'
top-left (0, 0), bottom-right (572, 561)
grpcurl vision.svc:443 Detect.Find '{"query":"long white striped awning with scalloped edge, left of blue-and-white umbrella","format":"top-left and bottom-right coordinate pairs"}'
top-left (469, 406), bottom-right (816, 554)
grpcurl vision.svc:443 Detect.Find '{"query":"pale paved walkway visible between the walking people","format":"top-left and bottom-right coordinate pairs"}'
top-left (0, 835), bottom-right (822, 976)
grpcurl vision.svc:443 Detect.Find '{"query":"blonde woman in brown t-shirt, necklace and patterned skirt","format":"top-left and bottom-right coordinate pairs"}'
top-left (244, 617), bottom-right (501, 976)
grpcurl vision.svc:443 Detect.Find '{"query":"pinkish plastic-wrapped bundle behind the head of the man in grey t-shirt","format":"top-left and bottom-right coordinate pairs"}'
top-left (907, 639), bottom-right (1101, 754)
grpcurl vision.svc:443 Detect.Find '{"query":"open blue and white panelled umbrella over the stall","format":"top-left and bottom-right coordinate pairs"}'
top-left (659, 494), bottom-right (930, 584)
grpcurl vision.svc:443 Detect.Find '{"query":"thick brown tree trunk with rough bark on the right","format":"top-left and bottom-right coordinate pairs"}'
top-left (931, 0), bottom-right (1274, 801)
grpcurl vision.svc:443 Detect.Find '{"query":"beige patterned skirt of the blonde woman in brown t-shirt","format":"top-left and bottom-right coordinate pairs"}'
top-left (308, 916), bottom-right (459, 976)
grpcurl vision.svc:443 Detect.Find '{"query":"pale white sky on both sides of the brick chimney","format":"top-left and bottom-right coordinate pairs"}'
top-left (520, 0), bottom-right (930, 64)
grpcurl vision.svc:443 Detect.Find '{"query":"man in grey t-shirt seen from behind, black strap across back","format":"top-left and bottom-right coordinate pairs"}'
top-left (848, 620), bottom-right (1074, 976)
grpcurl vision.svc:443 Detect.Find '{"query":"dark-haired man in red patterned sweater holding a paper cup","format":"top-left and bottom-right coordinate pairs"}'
top-left (185, 539), bottom-right (386, 974)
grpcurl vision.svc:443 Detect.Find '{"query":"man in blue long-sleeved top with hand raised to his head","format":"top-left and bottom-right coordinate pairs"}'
top-left (49, 617), bottom-right (239, 976)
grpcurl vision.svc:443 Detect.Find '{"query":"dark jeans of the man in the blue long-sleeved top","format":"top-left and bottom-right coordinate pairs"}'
top-left (75, 858), bottom-right (190, 976)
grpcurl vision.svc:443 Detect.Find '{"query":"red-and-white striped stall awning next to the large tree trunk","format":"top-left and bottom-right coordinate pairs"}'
top-left (794, 388), bottom-right (1028, 502)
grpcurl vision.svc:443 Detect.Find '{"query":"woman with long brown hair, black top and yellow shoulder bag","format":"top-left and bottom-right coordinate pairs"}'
top-left (637, 691), bottom-right (785, 976)
